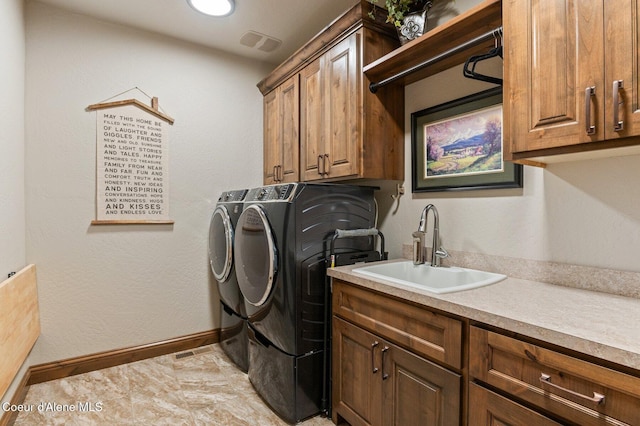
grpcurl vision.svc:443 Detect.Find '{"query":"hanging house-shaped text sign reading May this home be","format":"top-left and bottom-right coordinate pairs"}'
top-left (88, 89), bottom-right (173, 225)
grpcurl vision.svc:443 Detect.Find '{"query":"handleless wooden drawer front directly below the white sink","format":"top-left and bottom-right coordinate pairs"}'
top-left (333, 280), bottom-right (462, 369)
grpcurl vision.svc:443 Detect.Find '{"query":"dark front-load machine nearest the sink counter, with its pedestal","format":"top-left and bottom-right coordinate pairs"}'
top-left (235, 183), bottom-right (375, 423)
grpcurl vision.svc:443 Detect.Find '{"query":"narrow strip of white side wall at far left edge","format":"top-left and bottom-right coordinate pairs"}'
top-left (0, 0), bottom-right (26, 276)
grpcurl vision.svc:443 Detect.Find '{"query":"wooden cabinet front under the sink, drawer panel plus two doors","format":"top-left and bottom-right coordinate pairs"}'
top-left (332, 281), bottom-right (462, 426)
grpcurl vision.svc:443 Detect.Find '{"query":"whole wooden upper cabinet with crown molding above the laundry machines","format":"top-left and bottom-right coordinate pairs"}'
top-left (258, 0), bottom-right (404, 184)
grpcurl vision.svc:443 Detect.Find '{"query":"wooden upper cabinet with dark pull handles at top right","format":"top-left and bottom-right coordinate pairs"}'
top-left (503, 0), bottom-right (640, 160)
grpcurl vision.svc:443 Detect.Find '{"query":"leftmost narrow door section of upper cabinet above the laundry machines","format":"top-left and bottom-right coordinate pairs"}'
top-left (263, 75), bottom-right (299, 185)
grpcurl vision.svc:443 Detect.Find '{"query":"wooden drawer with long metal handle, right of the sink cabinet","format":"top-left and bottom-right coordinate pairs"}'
top-left (469, 327), bottom-right (640, 426)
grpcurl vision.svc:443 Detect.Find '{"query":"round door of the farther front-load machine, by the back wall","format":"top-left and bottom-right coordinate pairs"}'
top-left (209, 206), bottom-right (233, 282)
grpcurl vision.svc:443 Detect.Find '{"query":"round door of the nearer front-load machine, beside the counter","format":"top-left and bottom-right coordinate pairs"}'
top-left (235, 205), bottom-right (278, 306)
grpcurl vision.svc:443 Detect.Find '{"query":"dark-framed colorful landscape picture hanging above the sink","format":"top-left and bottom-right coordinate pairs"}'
top-left (411, 87), bottom-right (522, 192)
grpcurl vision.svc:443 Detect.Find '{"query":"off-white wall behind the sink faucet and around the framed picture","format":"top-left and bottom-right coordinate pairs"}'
top-left (379, 64), bottom-right (640, 272)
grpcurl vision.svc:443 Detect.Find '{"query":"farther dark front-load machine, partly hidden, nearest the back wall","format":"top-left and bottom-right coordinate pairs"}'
top-left (209, 189), bottom-right (249, 372)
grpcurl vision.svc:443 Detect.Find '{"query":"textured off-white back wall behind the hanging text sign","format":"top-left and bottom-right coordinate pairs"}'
top-left (26, 2), bottom-right (269, 364)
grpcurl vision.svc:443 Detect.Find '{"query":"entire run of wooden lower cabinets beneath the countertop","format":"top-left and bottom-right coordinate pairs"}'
top-left (331, 279), bottom-right (640, 426)
